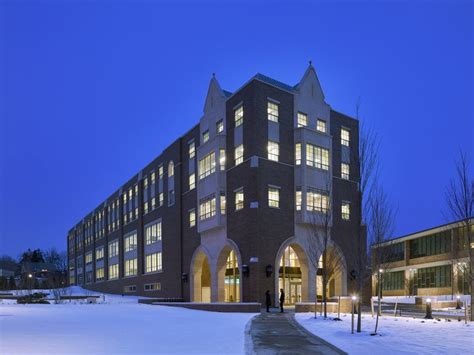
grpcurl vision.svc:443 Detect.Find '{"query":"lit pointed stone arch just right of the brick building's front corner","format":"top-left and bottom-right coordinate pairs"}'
top-left (274, 237), bottom-right (316, 304)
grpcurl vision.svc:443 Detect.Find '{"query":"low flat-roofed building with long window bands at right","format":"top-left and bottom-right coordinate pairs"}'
top-left (372, 222), bottom-right (474, 296)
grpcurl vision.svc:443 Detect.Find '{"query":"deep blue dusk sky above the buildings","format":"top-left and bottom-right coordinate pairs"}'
top-left (0, 0), bottom-right (474, 257)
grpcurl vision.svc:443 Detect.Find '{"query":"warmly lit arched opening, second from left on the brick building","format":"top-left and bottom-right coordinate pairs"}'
top-left (217, 241), bottom-right (242, 302)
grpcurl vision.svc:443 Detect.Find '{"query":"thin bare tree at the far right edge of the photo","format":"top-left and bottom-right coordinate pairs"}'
top-left (445, 152), bottom-right (474, 321)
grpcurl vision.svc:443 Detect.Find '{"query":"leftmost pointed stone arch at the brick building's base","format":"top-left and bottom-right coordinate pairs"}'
top-left (189, 245), bottom-right (213, 302)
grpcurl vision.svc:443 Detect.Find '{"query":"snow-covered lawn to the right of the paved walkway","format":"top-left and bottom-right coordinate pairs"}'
top-left (296, 313), bottom-right (474, 355)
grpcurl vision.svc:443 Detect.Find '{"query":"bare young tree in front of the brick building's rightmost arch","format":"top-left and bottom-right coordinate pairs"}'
top-left (306, 181), bottom-right (344, 318)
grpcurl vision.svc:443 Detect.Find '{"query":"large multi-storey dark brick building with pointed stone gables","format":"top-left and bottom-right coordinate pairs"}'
top-left (67, 64), bottom-right (365, 303)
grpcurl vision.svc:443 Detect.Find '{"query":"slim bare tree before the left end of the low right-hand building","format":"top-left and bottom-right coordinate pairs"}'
top-left (368, 185), bottom-right (395, 334)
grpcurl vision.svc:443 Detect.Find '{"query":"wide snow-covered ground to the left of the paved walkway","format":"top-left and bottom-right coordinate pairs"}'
top-left (0, 288), bottom-right (254, 355)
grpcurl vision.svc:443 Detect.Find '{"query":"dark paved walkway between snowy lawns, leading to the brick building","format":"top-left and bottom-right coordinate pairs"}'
top-left (250, 310), bottom-right (345, 355)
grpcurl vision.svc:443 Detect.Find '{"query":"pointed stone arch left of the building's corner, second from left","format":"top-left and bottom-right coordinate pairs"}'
top-left (216, 239), bottom-right (242, 302)
